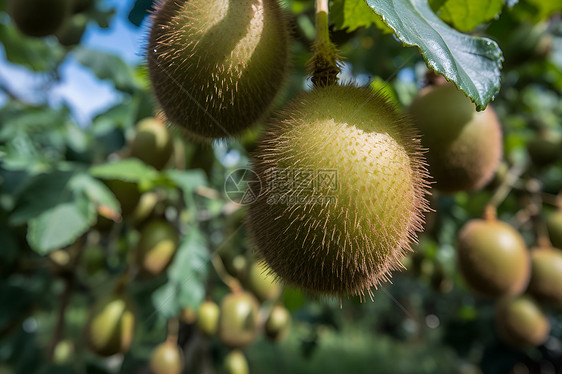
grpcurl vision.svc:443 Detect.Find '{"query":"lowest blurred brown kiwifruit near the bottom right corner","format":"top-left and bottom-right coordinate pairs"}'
top-left (496, 295), bottom-right (550, 348)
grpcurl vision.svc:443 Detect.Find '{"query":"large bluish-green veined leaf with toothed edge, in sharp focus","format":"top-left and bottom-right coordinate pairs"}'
top-left (366, 0), bottom-right (502, 110)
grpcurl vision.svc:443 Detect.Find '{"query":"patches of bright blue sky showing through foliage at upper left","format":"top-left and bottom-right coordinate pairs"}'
top-left (0, 0), bottom-right (147, 125)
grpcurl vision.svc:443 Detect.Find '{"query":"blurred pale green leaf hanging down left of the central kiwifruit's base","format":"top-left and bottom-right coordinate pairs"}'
top-left (152, 227), bottom-right (210, 318)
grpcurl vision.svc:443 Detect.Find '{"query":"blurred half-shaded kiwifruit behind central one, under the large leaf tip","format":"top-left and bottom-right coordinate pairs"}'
top-left (409, 83), bottom-right (502, 193)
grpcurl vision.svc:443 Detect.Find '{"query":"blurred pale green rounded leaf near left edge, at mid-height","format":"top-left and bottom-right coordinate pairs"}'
top-left (27, 196), bottom-right (96, 255)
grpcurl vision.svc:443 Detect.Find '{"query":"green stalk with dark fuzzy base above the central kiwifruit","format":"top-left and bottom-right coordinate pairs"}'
top-left (308, 0), bottom-right (341, 87)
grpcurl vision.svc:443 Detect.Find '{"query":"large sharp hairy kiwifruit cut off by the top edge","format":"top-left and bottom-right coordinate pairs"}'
top-left (148, 0), bottom-right (288, 139)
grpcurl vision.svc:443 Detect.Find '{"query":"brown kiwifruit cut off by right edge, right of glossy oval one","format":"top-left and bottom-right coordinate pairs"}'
top-left (529, 248), bottom-right (562, 307)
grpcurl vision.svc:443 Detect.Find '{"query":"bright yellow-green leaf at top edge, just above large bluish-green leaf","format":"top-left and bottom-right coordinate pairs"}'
top-left (437, 0), bottom-right (504, 31)
